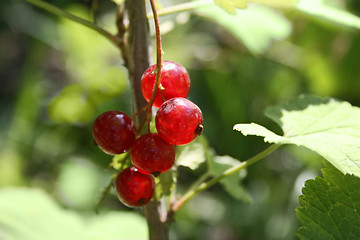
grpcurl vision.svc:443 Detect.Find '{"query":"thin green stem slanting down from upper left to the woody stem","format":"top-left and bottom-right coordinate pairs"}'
top-left (26, 0), bottom-right (119, 46)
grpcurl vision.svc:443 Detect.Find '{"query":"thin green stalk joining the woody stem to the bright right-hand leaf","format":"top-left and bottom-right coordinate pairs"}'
top-left (172, 145), bottom-right (279, 212)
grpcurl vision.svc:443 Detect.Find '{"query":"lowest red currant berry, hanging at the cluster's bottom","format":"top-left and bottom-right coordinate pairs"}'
top-left (115, 167), bottom-right (155, 207)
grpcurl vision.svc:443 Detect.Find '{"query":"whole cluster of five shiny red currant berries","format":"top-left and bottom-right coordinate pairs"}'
top-left (92, 61), bottom-right (203, 207)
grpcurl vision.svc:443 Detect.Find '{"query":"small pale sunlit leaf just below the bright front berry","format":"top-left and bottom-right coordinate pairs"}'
top-left (176, 142), bottom-right (205, 170)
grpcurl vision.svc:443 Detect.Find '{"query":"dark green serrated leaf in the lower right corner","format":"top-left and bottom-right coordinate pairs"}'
top-left (296, 164), bottom-right (360, 240)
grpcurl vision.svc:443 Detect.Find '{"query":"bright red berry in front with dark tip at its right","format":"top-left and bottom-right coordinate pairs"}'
top-left (155, 97), bottom-right (203, 145)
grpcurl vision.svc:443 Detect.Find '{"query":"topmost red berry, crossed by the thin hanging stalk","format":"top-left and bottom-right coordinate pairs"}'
top-left (141, 61), bottom-right (190, 107)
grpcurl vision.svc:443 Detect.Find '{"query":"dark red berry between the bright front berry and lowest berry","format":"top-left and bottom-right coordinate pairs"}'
top-left (131, 133), bottom-right (175, 175)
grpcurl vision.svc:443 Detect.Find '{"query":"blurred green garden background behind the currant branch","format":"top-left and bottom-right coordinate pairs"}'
top-left (0, 0), bottom-right (360, 240)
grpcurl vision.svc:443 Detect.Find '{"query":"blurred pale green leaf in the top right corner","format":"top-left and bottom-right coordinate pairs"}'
top-left (296, 0), bottom-right (360, 29)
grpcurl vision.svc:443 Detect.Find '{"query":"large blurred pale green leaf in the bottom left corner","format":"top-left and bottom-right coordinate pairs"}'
top-left (0, 188), bottom-right (148, 240)
